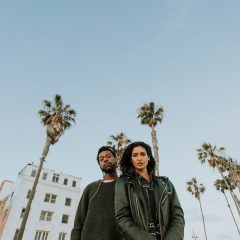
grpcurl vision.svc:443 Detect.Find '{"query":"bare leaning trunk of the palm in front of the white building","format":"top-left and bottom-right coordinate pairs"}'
top-left (17, 137), bottom-right (52, 240)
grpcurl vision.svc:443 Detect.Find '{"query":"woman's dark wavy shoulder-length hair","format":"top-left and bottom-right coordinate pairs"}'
top-left (119, 142), bottom-right (155, 174)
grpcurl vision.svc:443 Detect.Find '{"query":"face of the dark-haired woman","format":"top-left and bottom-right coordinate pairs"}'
top-left (131, 146), bottom-right (149, 172)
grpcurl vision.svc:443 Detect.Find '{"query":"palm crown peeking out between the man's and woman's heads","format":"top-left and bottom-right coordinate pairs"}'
top-left (107, 132), bottom-right (131, 164)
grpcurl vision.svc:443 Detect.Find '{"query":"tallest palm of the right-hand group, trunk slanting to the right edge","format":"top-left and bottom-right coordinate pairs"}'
top-left (197, 143), bottom-right (240, 215)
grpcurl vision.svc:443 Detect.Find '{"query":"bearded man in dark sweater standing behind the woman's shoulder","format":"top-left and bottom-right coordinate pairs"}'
top-left (71, 146), bottom-right (121, 240)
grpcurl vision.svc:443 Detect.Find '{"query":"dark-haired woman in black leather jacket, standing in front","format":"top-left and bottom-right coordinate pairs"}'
top-left (115, 142), bottom-right (184, 240)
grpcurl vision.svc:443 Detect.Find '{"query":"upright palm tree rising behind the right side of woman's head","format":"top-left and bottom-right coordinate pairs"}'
top-left (137, 102), bottom-right (164, 176)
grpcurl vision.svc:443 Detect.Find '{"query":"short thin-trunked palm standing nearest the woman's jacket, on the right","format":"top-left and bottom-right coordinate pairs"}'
top-left (187, 177), bottom-right (207, 240)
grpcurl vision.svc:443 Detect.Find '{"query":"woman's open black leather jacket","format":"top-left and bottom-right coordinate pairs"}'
top-left (115, 174), bottom-right (185, 240)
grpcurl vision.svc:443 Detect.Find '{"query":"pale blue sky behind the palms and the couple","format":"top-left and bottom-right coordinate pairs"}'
top-left (0, 0), bottom-right (240, 240)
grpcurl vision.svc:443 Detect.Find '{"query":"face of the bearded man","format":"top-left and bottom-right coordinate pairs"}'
top-left (98, 150), bottom-right (116, 173)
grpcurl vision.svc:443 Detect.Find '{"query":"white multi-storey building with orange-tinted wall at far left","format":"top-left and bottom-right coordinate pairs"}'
top-left (0, 164), bottom-right (81, 240)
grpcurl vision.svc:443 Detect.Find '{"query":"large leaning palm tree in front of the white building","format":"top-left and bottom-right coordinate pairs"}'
top-left (17, 95), bottom-right (76, 240)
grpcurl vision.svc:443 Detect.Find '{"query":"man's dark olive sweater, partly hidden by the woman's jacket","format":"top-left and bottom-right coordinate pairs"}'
top-left (71, 181), bottom-right (121, 240)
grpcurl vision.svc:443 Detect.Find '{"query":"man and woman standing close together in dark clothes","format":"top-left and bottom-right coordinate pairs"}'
top-left (71, 142), bottom-right (184, 240)
